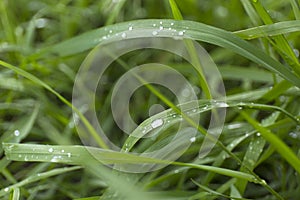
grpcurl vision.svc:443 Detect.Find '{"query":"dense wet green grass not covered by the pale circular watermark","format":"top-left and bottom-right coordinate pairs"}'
top-left (0, 0), bottom-right (300, 200)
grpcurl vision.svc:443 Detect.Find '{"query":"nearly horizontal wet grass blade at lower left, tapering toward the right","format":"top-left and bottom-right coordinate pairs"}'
top-left (3, 143), bottom-right (261, 184)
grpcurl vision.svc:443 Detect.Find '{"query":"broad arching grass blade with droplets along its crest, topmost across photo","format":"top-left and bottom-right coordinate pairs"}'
top-left (37, 20), bottom-right (300, 87)
